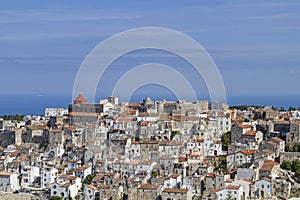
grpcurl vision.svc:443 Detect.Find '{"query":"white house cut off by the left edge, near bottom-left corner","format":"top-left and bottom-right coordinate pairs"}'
top-left (0, 171), bottom-right (19, 192)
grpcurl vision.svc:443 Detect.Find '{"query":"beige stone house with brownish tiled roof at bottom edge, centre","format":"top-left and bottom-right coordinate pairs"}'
top-left (137, 184), bottom-right (160, 200)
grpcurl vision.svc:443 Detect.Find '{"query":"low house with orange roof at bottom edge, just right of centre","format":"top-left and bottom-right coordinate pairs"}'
top-left (162, 188), bottom-right (192, 200)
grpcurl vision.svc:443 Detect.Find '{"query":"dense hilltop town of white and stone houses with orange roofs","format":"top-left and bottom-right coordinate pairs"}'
top-left (0, 94), bottom-right (300, 200)
